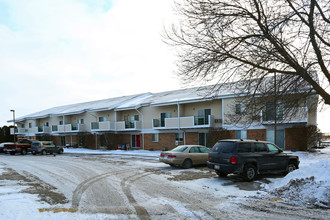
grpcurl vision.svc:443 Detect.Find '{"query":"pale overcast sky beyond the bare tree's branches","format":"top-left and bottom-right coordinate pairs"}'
top-left (0, 0), bottom-right (330, 132)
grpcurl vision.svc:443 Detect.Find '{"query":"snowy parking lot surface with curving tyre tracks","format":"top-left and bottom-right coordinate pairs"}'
top-left (0, 153), bottom-right (329, 219)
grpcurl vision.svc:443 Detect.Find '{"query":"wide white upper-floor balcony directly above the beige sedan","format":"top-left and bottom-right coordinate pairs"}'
top-left (152, 115), bottom-right (214, 129)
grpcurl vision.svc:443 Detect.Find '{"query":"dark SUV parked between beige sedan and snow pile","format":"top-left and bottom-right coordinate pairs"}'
top-left (207, 139), bottom-right (299, 181)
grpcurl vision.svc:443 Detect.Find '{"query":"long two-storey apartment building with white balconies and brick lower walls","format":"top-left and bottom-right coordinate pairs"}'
top-left (8, 83), bottom-right (317, 150)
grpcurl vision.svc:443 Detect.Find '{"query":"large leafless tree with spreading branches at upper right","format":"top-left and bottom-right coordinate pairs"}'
top-left (165, 0), bottom-right (330, 106)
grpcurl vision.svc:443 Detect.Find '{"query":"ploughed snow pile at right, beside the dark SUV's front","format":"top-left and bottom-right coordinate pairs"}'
top-left (265, 152), bottom-right (330, 208)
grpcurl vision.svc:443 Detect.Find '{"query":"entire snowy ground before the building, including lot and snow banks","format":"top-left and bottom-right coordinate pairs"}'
top-left (0, 148), bottom-right (330, 220)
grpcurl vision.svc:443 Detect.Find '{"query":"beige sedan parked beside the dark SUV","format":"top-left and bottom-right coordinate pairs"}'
top-left (159, 145), bottom-right (210, 169)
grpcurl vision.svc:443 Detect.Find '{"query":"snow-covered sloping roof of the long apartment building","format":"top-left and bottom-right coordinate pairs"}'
top-left (12, 76), bottom-right (310, 122)
